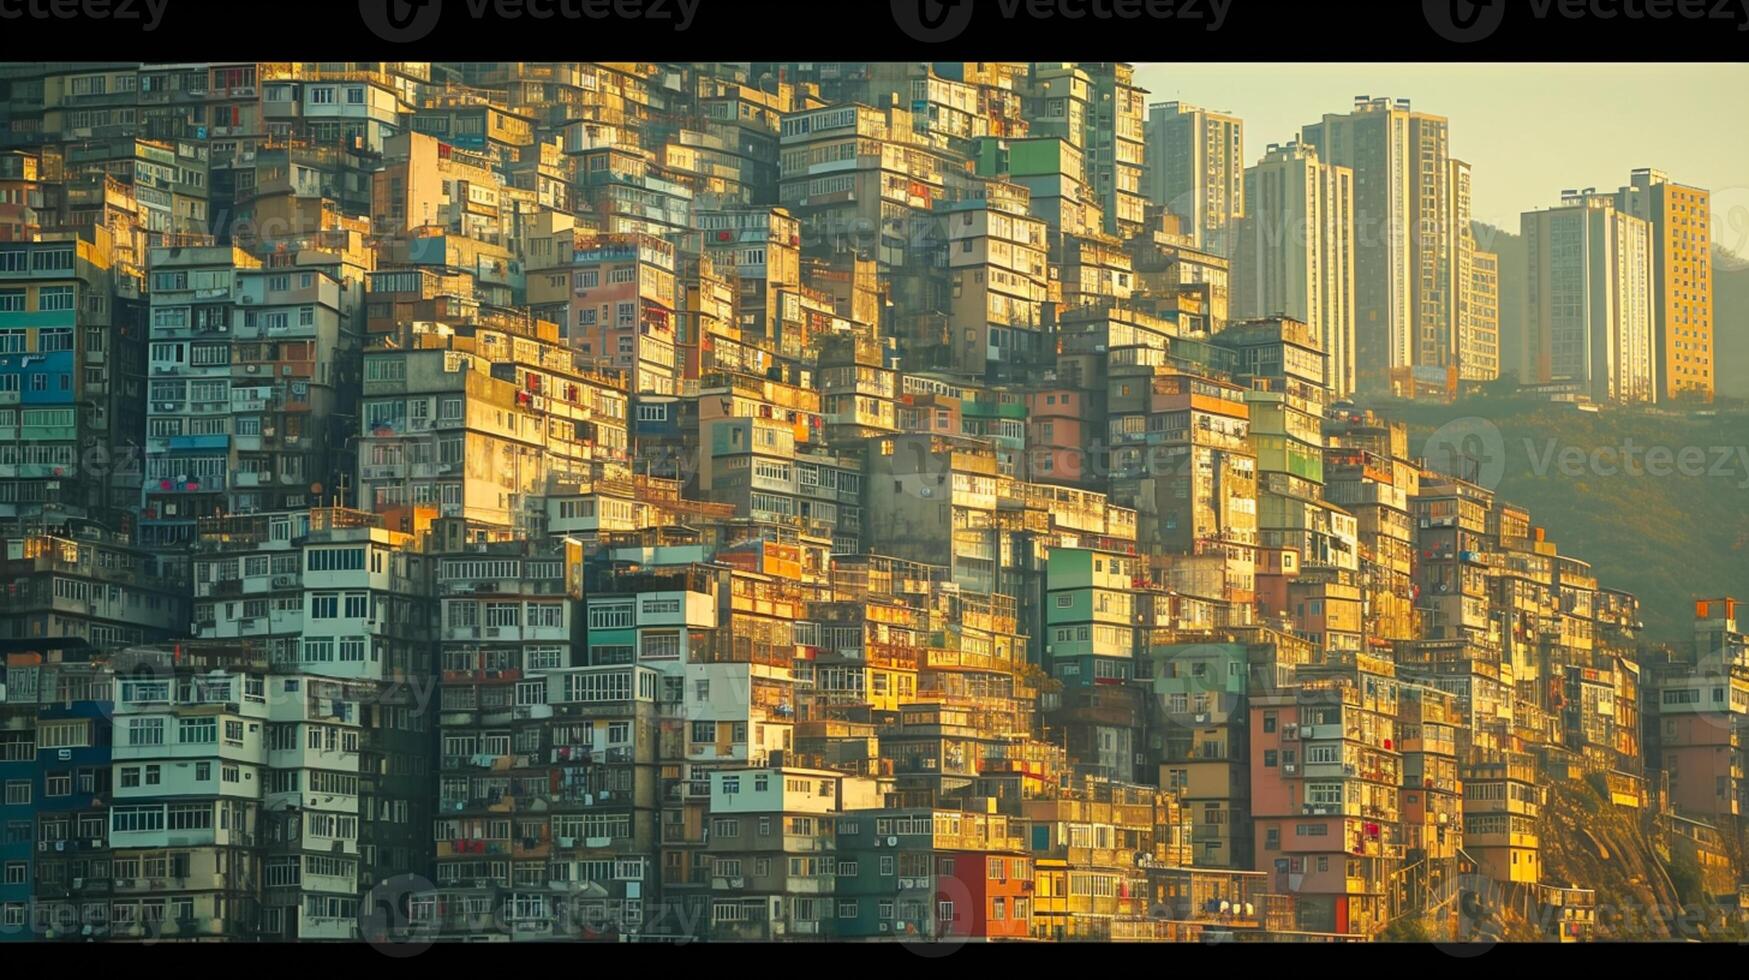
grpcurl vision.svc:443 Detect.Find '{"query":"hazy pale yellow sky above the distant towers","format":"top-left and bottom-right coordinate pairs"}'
top-left (1137, 63), bottom-right (1749, 241)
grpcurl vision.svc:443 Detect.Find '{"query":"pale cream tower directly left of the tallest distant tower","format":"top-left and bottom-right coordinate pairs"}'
top-left (1233, 144), bottom-right (1355, 399)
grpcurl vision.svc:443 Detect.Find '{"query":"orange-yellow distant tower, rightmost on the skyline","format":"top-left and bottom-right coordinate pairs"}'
top-left (1616, 168), bottom-right (1718, 401)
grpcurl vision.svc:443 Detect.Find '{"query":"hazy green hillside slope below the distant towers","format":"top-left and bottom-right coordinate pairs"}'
top-left (1376, 397), bottom-right (1749, 641)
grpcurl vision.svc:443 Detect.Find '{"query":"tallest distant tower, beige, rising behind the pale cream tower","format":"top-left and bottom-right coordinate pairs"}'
top-left (1301, 96), bottom-right (1457, 392)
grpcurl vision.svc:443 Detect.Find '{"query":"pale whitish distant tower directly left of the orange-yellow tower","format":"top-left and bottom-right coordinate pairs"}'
top-left (1522, 191), bottom-right (1658, 403)
